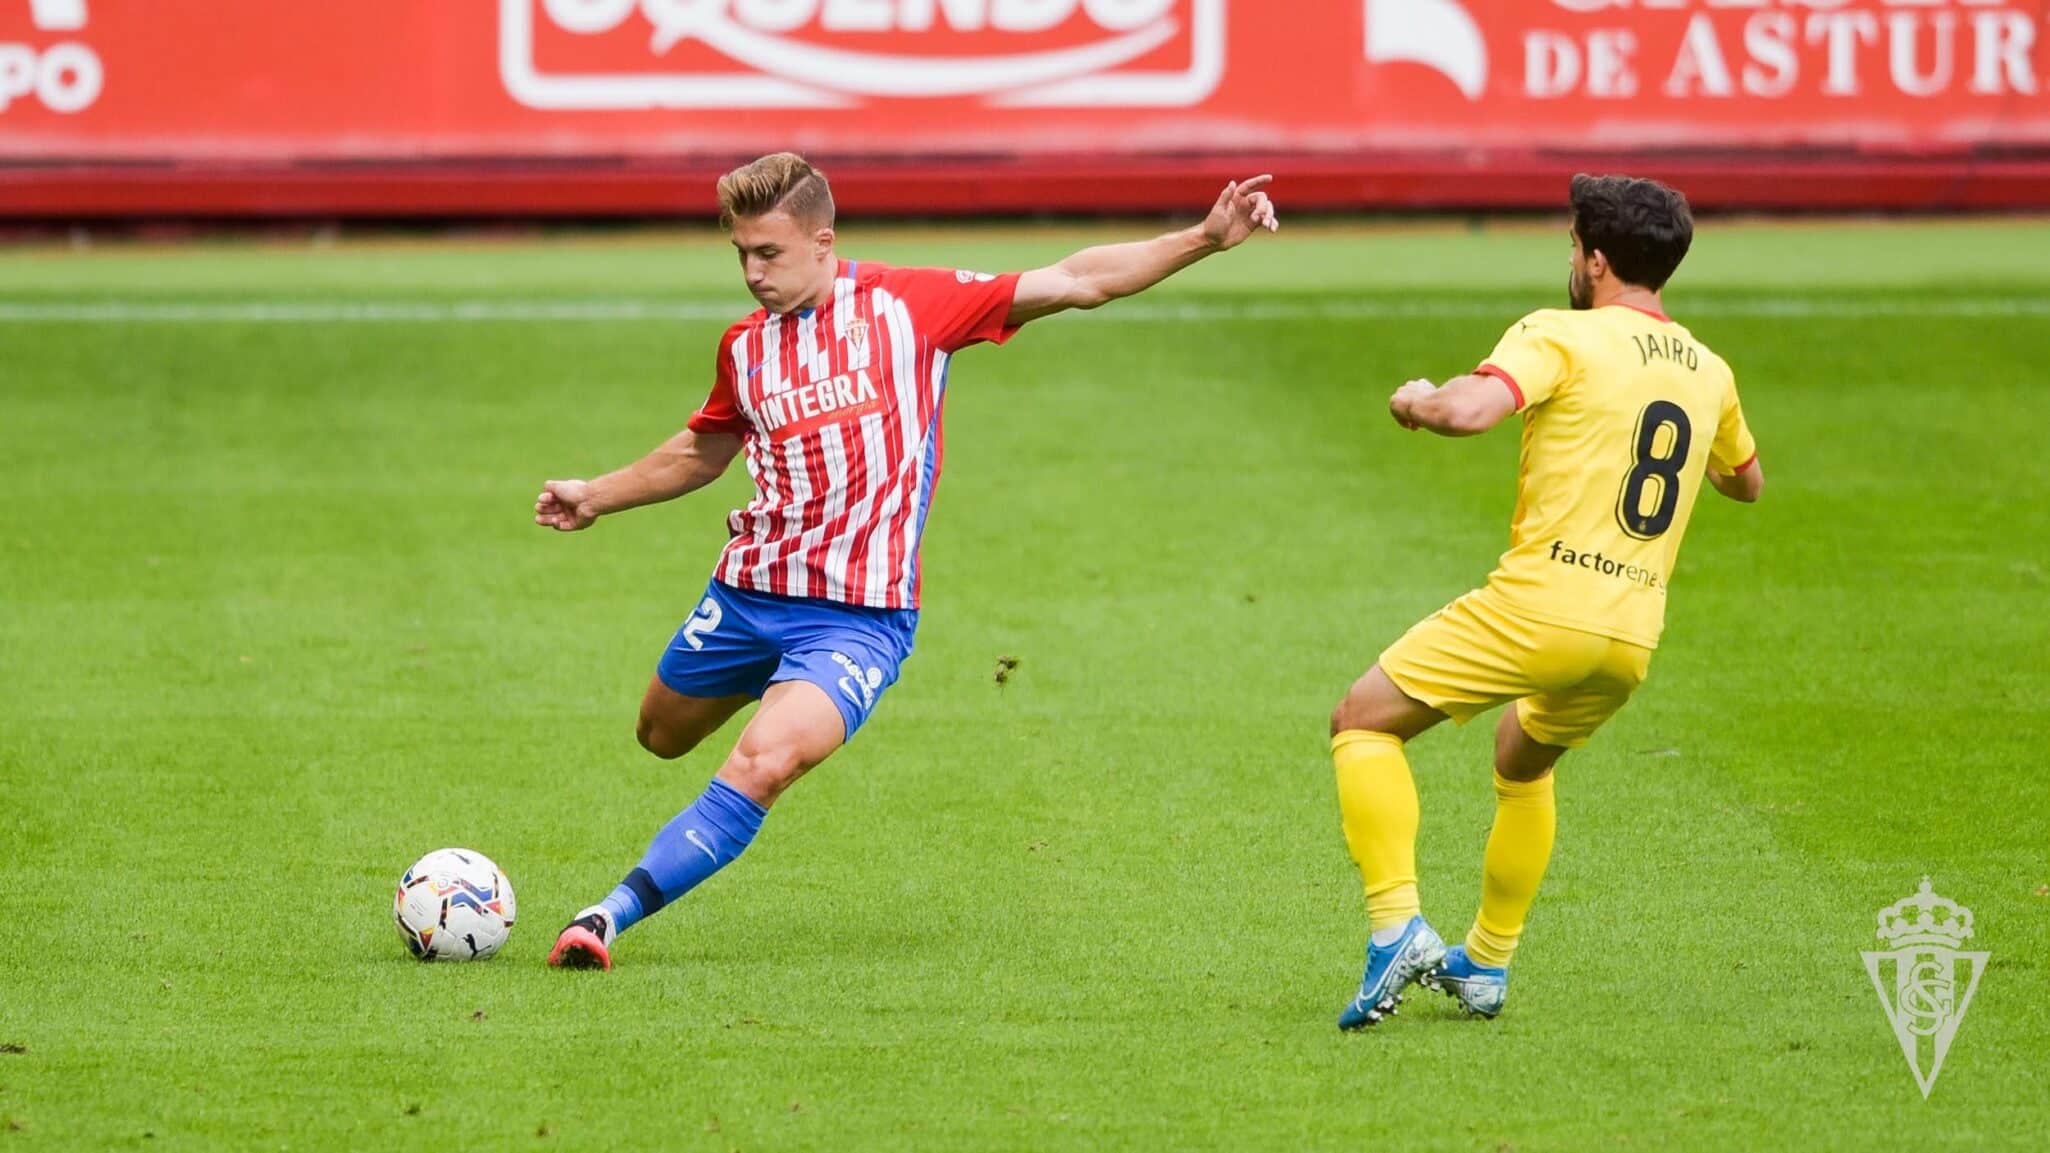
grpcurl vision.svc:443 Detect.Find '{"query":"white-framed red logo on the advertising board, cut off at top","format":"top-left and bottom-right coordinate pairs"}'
top-left (498, 0), bottom-right (1224, 111)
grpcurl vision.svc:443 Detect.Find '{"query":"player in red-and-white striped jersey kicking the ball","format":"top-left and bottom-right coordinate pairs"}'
top-left (533, 152), bottom-right (1277, 968)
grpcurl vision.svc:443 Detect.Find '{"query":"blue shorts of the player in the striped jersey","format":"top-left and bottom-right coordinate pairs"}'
top-left (656, 581), bottom-right (918, 741)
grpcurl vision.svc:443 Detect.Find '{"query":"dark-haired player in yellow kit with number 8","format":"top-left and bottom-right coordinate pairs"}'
top-left (1330, 176), bottom-right (1765, 1030)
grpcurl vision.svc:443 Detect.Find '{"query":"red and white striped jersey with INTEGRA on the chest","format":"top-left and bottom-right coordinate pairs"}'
top-left (691, 261), bottom-right (1017, 609)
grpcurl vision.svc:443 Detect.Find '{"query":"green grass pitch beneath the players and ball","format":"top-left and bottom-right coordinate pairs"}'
top-left (0, 217), bottom-right (2050, 1153)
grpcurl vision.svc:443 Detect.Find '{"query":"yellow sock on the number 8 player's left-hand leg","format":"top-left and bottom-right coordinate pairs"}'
top-left (1330, 728), bottom-right (1419, 929)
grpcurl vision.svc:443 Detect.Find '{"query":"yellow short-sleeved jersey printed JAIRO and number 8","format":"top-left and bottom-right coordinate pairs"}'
top-left (1478, 304), bottom-right (1757, 648)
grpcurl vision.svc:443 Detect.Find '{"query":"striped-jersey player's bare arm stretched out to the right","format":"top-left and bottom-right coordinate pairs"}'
top-left (1005, 176), bottom-right (1281, 326)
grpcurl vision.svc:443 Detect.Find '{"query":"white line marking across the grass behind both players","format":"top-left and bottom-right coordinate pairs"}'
top-left (0, 295), bottom-right (2050, 324)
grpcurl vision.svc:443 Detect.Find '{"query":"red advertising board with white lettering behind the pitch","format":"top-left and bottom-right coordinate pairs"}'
top-left (0, 0), bottom-right (2050, 215)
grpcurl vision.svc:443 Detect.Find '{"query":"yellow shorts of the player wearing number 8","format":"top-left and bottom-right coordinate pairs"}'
top-left (1380, 589), bottom-right (1652, 749)
